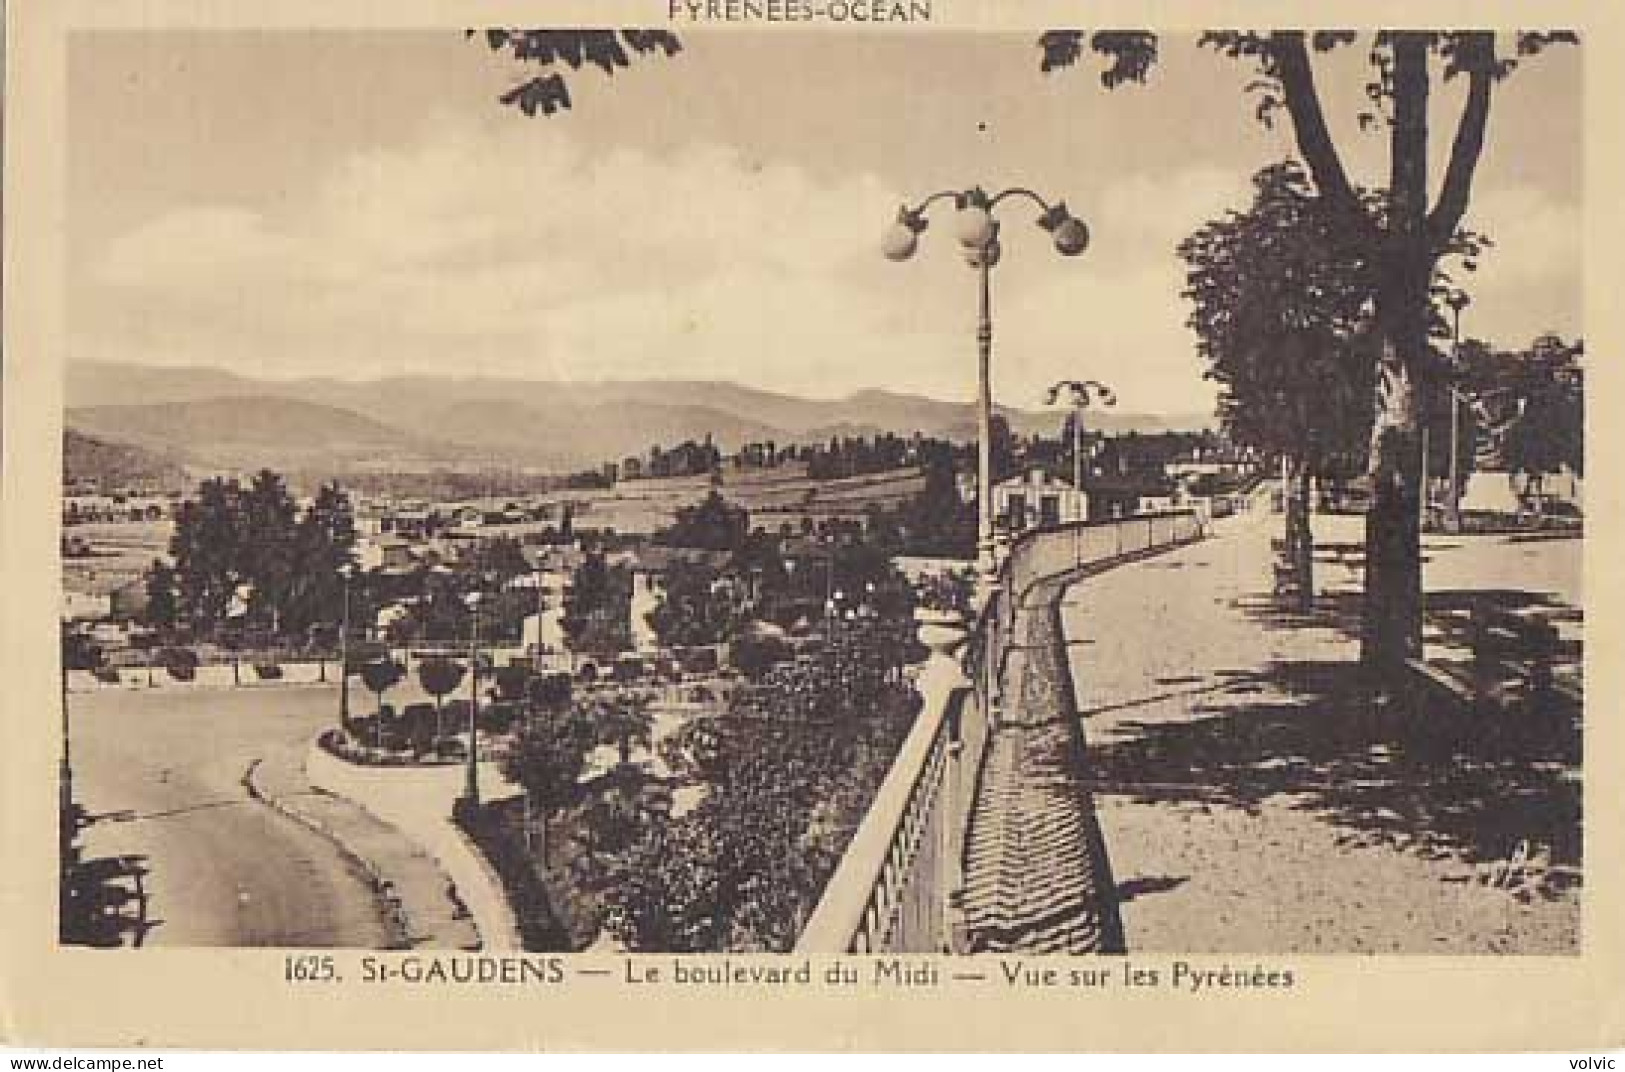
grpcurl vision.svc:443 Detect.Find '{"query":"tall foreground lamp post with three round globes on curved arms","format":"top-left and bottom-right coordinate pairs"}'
top-left (881, 187), bottom-right (1089, 594)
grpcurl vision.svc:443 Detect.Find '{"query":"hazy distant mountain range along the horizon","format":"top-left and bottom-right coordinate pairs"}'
top-left (67, 362), bottom-right (1212, 471)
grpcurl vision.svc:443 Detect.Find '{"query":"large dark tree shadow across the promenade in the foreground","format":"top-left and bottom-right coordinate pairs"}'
top-left (1089, 652), bottom-right (1581, 866)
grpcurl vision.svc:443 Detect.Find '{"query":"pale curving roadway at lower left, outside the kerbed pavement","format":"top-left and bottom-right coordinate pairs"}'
top-left (68, 687), bottom-right (388, 949)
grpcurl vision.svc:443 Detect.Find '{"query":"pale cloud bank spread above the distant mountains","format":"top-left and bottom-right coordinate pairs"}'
top-left (75, 122), bottom-right (1573, 411)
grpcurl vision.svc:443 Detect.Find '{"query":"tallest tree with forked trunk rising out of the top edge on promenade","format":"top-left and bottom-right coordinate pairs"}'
top-left (1040, 31), bottom-right (1576, 669)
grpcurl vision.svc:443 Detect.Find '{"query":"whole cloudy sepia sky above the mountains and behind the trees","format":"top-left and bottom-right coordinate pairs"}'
top-left (67, 29), bottom-right (1583, 413)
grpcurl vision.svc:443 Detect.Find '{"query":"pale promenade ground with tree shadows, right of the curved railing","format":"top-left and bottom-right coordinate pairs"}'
top-left (1063, 515), bottom-right (1580, 953)
